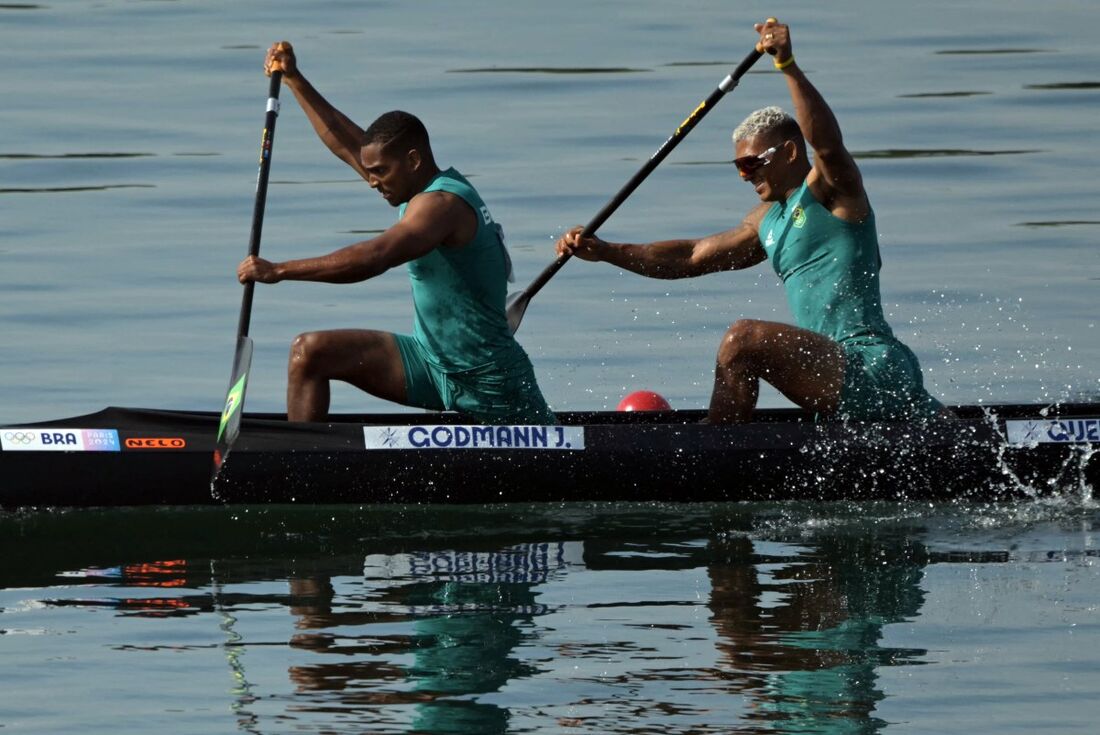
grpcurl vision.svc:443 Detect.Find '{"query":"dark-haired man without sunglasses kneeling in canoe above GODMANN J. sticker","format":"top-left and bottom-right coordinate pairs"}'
top-left (238, 42), bottom-right (557, 424)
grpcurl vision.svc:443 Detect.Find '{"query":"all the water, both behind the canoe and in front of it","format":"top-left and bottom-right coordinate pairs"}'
top-left (0, 0), bottom-right (1100, 735)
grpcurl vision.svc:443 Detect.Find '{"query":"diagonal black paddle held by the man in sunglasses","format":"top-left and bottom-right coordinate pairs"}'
top-left (507, 48), bottom-right (763, 333)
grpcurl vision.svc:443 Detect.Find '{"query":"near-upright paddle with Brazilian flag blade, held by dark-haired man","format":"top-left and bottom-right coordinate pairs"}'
top-left (211, 72), bottom-right (283, 482)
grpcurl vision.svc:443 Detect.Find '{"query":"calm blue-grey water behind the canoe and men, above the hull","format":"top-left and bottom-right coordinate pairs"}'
top-left (0, 0), bottom-right (1100, 423)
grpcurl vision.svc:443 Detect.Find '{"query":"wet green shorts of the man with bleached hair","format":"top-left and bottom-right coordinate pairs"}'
top-left (835, 340), bottom-right (944, 421)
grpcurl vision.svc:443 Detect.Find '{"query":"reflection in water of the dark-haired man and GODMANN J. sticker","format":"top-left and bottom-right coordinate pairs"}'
top-left (289, 544), bottom-right (564, 733)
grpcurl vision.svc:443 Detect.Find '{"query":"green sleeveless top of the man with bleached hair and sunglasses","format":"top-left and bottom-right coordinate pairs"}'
top-left (759, 182), bottom-right (893, 343)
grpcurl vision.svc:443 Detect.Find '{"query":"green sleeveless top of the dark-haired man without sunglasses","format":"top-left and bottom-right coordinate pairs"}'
top-left (398, 168), bottom-right (526, 373)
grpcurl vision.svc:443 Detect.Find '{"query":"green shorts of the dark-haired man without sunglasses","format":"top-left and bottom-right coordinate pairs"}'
top-left (394, 334), bottom-right (558, 426)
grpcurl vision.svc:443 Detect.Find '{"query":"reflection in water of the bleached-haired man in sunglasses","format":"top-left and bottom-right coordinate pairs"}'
top-left (710, 530), bottom-right (926, 733)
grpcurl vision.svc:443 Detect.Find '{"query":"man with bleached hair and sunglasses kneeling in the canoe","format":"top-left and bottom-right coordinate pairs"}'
top-left (558, 20), bottom-right (948, 424)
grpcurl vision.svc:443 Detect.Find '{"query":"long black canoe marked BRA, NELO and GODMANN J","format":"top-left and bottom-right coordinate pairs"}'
top-left (0, 404), bottom-right (1100, 508)
